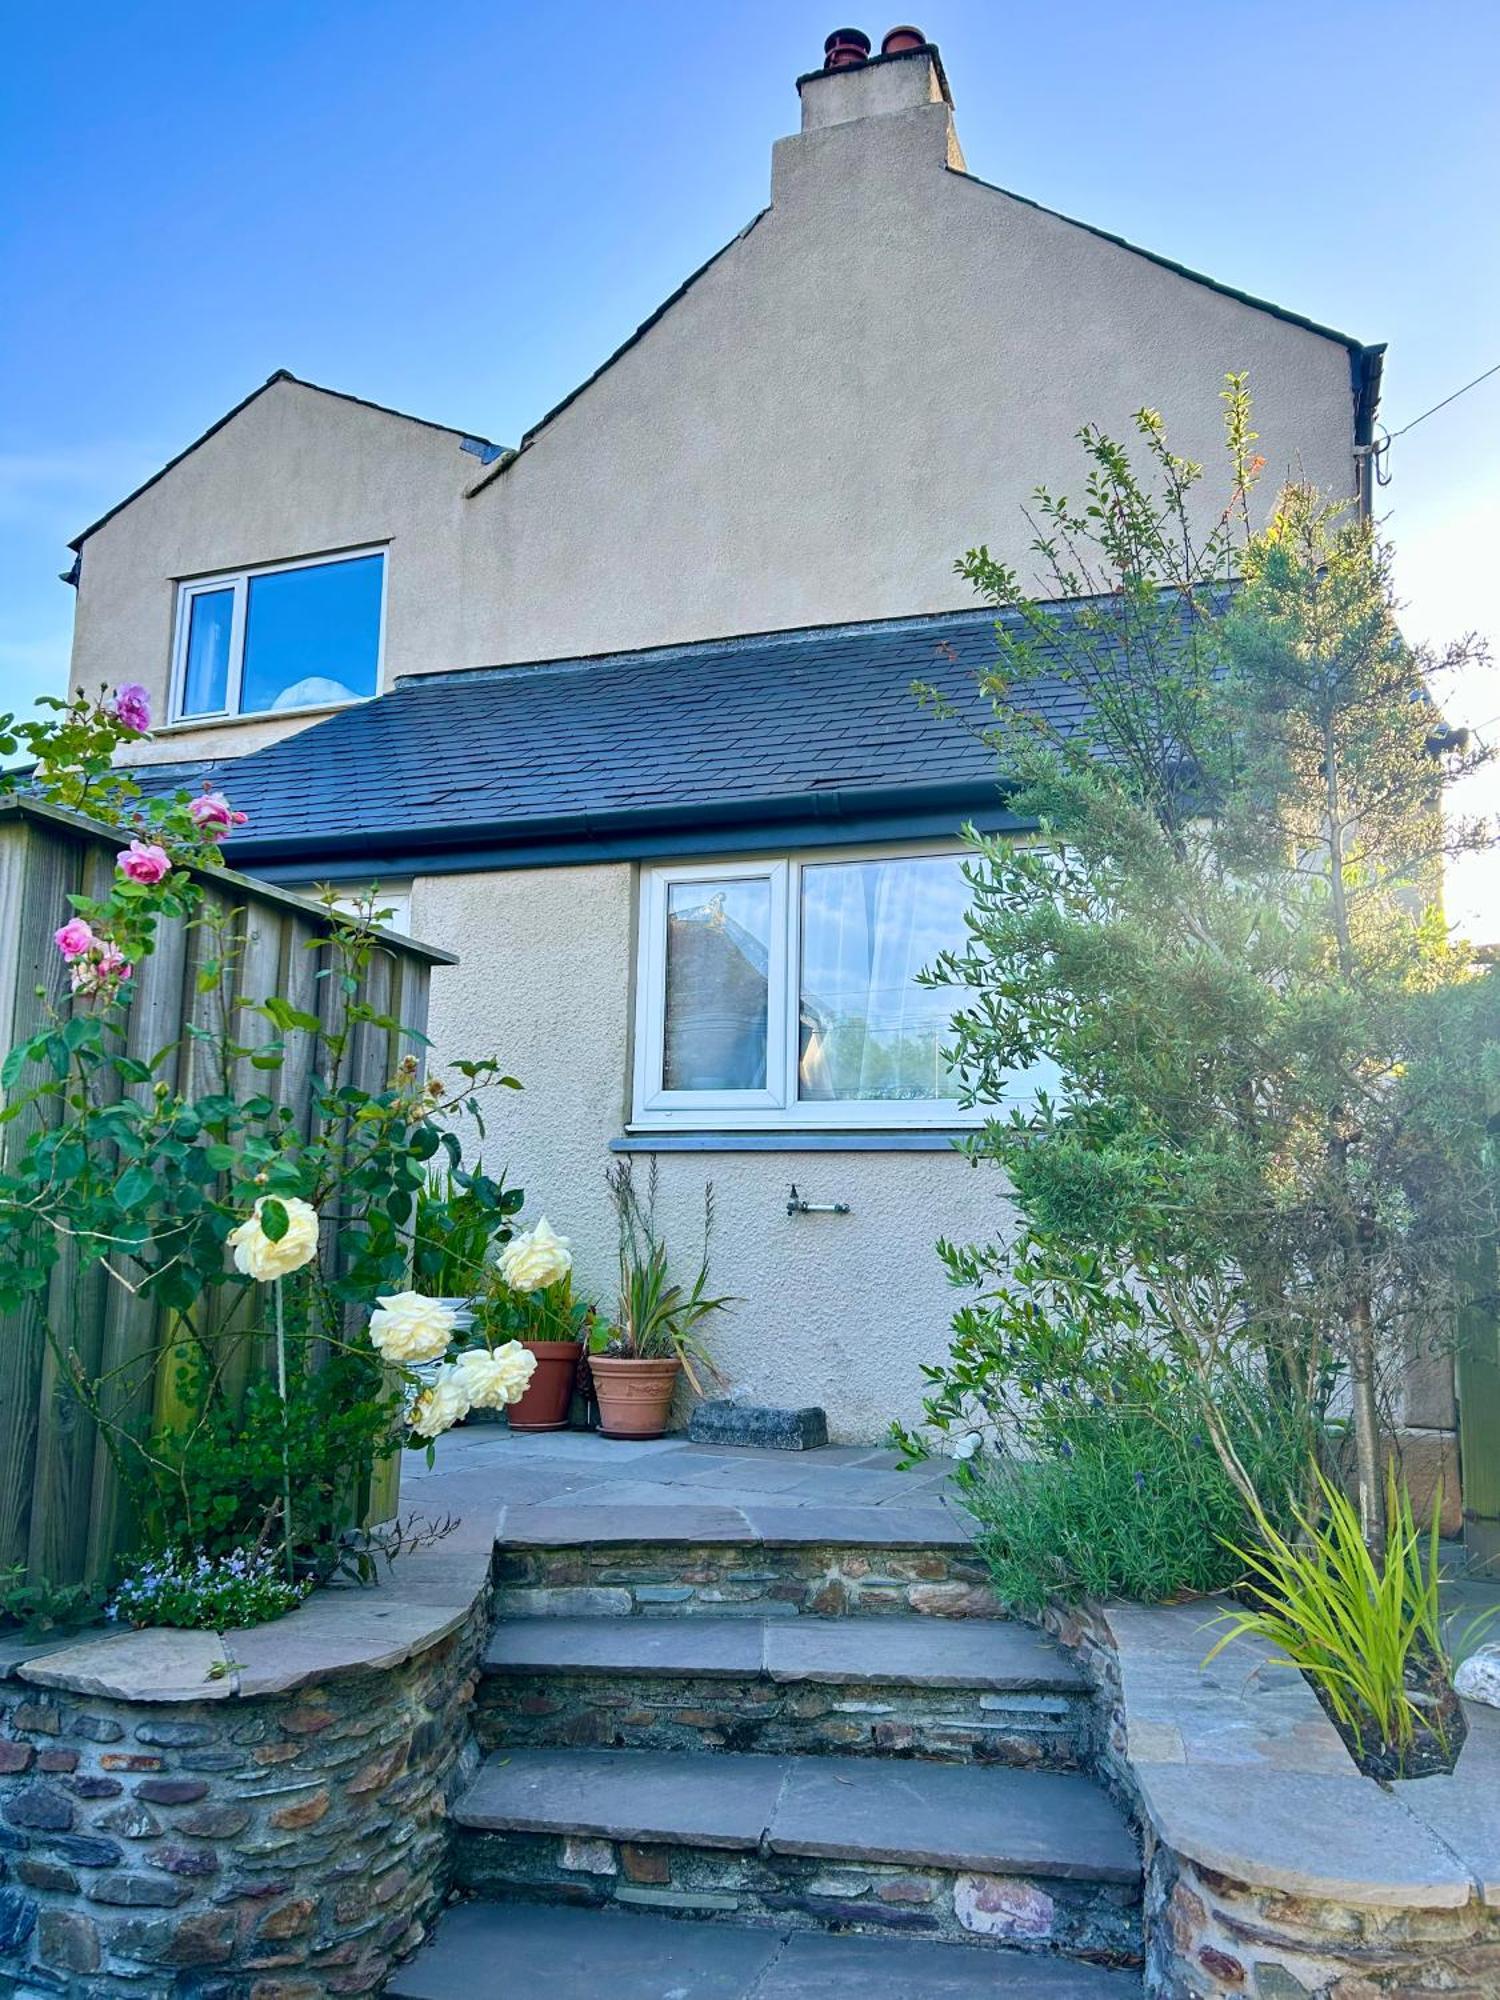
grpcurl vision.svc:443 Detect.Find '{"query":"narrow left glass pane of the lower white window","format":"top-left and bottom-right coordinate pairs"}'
top-left (662, 876), bottom-right (770, 1090)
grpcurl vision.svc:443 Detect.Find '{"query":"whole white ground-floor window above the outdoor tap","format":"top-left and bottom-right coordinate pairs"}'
top-left (632, 846), bottom-right (1034, 1132)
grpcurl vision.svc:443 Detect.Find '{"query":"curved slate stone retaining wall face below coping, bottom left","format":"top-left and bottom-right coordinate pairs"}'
top-left (0, 1602), bottom-right (488, 2000)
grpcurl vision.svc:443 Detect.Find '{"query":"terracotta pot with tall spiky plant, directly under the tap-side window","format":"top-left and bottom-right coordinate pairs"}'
top-left (588, 1160), bottom-right (730, 1438)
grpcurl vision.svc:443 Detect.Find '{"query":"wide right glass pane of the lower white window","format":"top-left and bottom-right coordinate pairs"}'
top-left (798, 854), bottom-right (968, 1102)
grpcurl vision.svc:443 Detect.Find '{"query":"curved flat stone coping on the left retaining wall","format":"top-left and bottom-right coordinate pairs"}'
top-left (0, 1506), bottom-right (494, 1702)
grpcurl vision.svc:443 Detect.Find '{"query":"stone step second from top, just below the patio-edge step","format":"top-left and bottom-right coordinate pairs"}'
top-left (476, 1616), bottom-right (1092, 1770)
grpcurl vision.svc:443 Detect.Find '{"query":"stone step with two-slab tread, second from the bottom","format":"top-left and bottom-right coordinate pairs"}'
top-left (454, 1750), bottom-right (1140, 1964)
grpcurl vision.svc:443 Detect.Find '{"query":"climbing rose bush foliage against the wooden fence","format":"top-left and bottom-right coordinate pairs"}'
top-left (0, 688), bottom-right (520, 1574)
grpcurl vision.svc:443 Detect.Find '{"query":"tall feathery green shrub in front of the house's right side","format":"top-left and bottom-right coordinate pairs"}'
top-left (916, 380), bottom-right (1500, 1540)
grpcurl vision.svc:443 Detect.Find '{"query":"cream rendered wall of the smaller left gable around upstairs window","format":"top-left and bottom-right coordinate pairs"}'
top-left (70, 380), bottom-right (480, 762)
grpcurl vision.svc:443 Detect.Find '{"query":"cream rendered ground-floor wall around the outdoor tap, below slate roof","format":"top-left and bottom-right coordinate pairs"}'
top-left (412, 864), bottom-right (1012, 1442)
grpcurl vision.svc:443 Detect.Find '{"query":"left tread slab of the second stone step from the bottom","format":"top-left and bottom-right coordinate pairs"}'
top-left (454, 1750), bottom-right (786, 1848)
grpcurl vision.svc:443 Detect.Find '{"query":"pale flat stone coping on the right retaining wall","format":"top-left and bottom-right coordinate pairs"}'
top-left (1096, 1598), bottom-right (1500, 1910)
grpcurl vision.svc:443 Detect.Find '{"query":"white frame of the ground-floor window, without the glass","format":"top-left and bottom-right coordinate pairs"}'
top-left (626, 840), bottom-right (992, 1132)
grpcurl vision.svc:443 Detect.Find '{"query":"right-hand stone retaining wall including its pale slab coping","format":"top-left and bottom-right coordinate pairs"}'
top-left (1046, 1602), bottom-right (1500, 2000)
